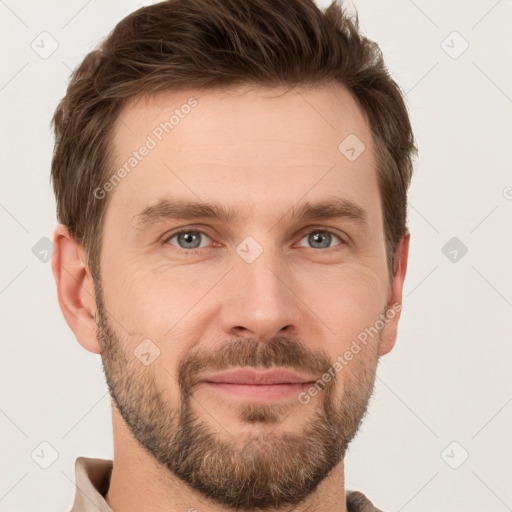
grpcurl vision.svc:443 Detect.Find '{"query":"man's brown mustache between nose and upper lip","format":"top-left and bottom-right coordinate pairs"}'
top-left (177, 336), bottom-right (331, 394)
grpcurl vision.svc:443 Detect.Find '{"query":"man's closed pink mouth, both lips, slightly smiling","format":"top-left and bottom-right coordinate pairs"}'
top-left (200, 368), bottom-right (316, 402)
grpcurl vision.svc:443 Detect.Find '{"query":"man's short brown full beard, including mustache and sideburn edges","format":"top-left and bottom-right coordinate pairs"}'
top-left (96, 286), bottom-right (380, 510)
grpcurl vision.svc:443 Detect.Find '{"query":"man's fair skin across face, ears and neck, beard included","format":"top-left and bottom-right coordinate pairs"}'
top-left (52, 84), bottom-right (410, 512)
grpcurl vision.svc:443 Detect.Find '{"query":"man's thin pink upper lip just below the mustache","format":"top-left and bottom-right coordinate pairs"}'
top-left (200, 368), bottom-right (317, 386)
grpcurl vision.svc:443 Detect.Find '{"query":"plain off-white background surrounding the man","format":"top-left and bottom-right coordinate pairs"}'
top-left (0, 0), bottom-right (512, 512)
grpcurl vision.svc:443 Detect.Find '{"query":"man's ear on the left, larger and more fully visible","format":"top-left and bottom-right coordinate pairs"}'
top-left (52, 224), bottom-right (101, 354)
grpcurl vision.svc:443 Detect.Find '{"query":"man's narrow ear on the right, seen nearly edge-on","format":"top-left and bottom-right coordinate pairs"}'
top-left (380, 228), bottom-right (411, 356)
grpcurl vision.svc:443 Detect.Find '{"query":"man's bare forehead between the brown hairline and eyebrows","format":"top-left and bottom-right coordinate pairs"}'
top-left (107, 84), bottom-right (379, 232)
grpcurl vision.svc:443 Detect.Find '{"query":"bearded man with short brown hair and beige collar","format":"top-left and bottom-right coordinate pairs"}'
top-left (52, 0), bottom-right (416, 512)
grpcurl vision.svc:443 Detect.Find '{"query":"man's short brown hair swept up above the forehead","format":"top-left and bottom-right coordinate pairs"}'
top-left (51, 0), bottom-right (417, 279)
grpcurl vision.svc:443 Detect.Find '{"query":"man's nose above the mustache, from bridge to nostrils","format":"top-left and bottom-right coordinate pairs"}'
top-left (221, 246), bottom-right (302, 341)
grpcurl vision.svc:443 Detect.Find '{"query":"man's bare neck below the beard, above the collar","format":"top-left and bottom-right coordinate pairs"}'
top-left (105, 406), bottom-right (347, 512)
